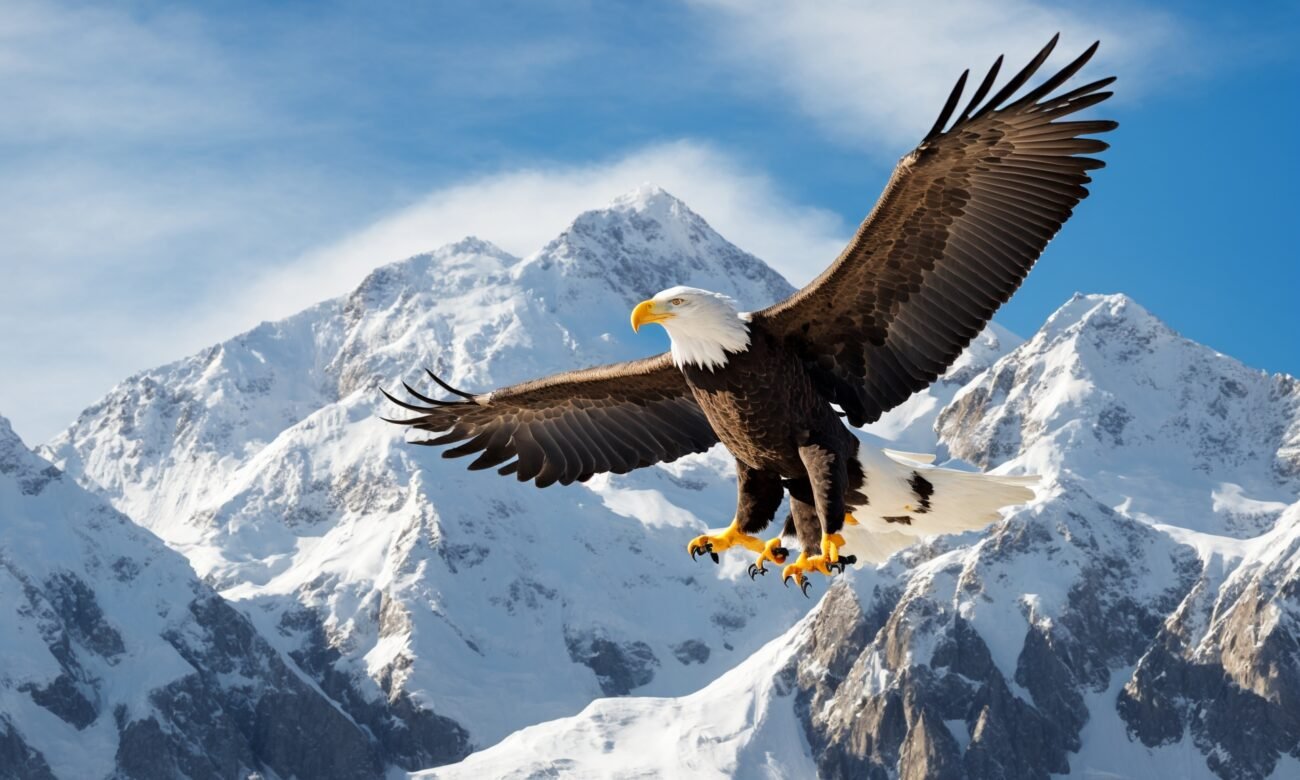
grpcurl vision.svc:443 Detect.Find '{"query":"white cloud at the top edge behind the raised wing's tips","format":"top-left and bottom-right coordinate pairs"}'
top-left (694, 0), bottom-right (1182, 146)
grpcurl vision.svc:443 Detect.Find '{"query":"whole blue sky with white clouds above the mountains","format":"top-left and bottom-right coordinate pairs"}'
top-left (0, 0), bottom-right (1300, 442)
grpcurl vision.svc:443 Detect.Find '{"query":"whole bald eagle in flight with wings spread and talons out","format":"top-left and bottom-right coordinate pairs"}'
top-left (385, 38), bottom-right (1117, 594)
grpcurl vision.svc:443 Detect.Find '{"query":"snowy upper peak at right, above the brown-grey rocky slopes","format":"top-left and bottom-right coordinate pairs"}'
top-left (937, 295), bottom-right (1300, 537)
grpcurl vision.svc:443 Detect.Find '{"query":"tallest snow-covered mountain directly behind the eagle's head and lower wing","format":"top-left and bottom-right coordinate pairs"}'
top-left (44, 189), bottom-right (894, 768)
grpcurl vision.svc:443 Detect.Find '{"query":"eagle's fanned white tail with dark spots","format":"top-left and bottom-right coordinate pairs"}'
top-left (842, 445), bottom-right (1039, 564)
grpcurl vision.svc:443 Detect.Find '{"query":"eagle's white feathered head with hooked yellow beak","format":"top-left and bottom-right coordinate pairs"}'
top-left (632, 286), bottom-right (749, 371)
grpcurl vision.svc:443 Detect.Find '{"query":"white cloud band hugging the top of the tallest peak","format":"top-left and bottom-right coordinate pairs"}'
top-left (208, 142), bottom-right (847, 333)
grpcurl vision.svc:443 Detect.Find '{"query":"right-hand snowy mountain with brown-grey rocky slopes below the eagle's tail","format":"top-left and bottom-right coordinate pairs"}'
top-left (429, 295), bottom-right (1300, 779)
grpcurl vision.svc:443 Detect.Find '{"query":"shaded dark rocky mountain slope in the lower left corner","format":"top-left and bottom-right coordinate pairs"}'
top-left (0, 417), bottom-right (431, 779)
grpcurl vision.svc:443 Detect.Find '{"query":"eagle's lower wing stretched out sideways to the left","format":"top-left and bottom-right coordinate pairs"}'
top-left (385, 354), bottom-right (718, 488)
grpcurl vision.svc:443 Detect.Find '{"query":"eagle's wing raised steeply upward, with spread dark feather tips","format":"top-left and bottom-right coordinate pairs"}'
top-left (753, 38), bottom-right (1117, 425)
